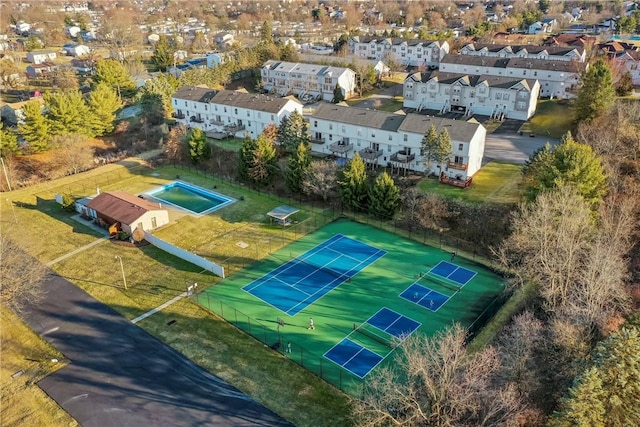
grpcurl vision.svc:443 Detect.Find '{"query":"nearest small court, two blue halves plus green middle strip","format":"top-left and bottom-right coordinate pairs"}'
top-left (324, 307), bottom-right (420, 378)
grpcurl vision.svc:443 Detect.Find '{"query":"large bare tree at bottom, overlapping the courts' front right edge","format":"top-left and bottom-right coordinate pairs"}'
top-left (354, 325), bottom-right (522, 426)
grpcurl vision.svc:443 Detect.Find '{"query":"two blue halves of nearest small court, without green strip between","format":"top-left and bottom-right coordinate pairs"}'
top-left (324, 307), bottom-right (421, 378)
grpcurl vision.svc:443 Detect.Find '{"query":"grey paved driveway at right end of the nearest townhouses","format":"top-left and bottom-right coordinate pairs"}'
top-left (484, 133), bottom-right (558, 164)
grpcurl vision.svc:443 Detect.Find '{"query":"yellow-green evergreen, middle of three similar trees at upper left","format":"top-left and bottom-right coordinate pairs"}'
top-left (44, 92), bottom-right (95, 137)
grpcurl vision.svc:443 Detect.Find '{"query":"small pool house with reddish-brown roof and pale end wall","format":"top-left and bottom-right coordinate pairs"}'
top-left (76, 191), bottom-right (169, 234)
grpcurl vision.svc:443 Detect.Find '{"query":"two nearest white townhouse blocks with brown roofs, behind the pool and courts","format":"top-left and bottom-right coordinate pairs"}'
top-left (171, 86), bottom-right (486, 183)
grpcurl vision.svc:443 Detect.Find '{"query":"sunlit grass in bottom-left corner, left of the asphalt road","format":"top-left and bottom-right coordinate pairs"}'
top-left (0, 307), bottom-right (78, 427)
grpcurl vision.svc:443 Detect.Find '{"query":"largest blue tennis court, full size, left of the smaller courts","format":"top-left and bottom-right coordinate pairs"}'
top-left (242, 234), bottom-right (387, 316)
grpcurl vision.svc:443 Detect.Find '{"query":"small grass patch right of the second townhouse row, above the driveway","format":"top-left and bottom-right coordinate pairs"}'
top-left (520, 99), bottom-right (575, 138)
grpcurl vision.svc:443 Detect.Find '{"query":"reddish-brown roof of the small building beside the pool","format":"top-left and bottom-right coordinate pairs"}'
top-left (87, 191), bottom-right (162, 224)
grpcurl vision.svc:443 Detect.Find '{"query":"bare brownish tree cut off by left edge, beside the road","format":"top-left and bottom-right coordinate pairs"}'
top-left (0, 235), bottom-right (46, 313)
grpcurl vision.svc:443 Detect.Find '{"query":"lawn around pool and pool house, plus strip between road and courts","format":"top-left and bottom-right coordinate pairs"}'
top-left (0, 159), bottom-right (350, 426)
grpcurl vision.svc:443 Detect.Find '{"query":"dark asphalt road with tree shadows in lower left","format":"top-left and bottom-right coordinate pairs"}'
top-left (25, 275), bottom-right (290, 427)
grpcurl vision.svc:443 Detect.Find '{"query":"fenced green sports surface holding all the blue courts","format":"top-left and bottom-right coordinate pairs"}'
top-left (197, 219), bottom-right (503, 392)
